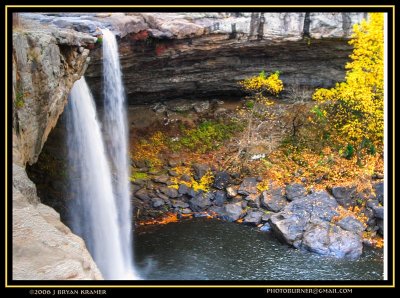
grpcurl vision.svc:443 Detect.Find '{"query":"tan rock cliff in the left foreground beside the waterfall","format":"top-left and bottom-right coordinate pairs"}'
top-left (12, 19), bottom-right (102, 280)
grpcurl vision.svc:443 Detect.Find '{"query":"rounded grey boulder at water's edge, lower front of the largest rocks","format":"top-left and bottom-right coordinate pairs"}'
top-left (301, 222), bottom-right (363, 259)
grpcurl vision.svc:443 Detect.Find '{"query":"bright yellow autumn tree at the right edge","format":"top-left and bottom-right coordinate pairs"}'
top-left (313, 13), bottom-right (384, 161)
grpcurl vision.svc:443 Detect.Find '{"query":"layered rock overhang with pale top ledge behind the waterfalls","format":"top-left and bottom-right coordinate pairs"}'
top-left (21, 12), bottom-right (366, 104)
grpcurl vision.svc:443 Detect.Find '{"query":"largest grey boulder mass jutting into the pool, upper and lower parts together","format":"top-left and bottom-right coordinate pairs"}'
top-left (270, 191), bottom-right (364, 258)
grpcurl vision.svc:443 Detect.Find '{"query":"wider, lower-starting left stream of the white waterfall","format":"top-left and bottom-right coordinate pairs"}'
top-left (66, 77), bottom-right (128, 279)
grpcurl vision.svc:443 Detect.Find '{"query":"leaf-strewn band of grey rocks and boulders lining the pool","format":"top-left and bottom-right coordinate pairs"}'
top-left (132, 160), bottom-right (384, 258)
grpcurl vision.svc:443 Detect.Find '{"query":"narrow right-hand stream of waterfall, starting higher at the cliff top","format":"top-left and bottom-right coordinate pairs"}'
top-left (102, 29), bottom-right (137, 272)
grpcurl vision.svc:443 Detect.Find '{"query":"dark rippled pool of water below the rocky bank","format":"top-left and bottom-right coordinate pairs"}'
top-left (135, 218), bottom-right (383, 280)
